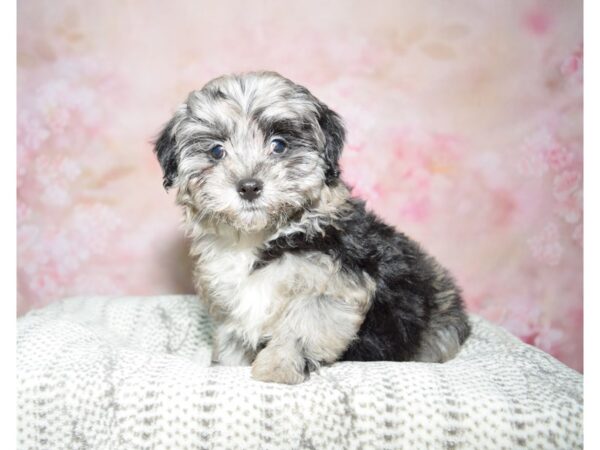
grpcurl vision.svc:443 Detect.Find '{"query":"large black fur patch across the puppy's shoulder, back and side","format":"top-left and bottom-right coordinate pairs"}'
top-left (254, 190), bottom-right (469, 361)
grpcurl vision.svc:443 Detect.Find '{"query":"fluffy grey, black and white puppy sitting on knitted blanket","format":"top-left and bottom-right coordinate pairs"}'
top-left (155, 72), bottom-right (469, 384)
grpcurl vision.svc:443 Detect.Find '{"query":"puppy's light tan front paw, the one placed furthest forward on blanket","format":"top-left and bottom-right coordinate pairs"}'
top-left (252, 347), bottom-right (305, 384)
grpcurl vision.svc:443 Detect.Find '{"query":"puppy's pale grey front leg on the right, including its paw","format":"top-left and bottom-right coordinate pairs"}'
top-left (252, 296), bottom-right (364, 384)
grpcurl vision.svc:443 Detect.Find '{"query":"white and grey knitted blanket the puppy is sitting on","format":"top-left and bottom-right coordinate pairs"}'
top-left (17, 296), bottom-right (583, 450)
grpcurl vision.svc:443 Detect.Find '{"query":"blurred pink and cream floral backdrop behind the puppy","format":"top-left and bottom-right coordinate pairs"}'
top-left (17, 0), bottom-right (583, 370)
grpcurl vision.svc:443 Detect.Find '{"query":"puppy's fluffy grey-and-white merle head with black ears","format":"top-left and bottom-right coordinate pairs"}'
top-left (155, 72), bottom-right (344, 232)
